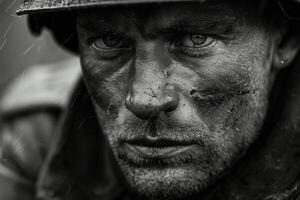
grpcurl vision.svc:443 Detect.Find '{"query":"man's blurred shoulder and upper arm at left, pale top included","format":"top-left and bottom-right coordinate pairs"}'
top-left (0, 59), bottom-right (80, 199)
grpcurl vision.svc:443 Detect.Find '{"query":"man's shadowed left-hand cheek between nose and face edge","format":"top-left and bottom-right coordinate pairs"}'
top-left (81, 52), bottom-right (129, 115)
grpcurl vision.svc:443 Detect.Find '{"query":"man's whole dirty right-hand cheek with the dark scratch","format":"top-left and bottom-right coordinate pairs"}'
top-left (171, 38), bottom-right (271, 139)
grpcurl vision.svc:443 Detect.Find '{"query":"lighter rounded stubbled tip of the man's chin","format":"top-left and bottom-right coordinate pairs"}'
top-left (119, 166), bottom-right (213, 200)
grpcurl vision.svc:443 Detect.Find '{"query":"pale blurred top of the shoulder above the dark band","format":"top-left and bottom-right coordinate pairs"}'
top-left (0, 58), bottom-right (80, 114)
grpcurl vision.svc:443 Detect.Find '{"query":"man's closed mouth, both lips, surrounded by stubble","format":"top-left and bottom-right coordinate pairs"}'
top-left (121, 137), bottom-right (196, 164)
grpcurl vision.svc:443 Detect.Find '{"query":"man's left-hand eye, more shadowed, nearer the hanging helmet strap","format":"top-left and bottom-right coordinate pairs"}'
top-left (93, 34), bottom-right (130, 50)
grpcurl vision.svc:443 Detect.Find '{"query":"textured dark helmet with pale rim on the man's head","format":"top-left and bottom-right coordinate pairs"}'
top-left (17, 0), bottom-right (300, 53)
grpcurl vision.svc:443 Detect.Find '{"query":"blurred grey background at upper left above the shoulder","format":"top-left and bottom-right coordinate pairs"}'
top-left (0, 0), bottom-right (73, 96)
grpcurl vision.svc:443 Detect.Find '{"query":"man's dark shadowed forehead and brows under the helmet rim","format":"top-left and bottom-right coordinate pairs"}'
top-left (75, 1), bottom-right (248, 37)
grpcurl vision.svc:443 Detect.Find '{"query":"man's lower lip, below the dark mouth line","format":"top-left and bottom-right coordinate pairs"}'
top-left (124, 143), bottom-right (194, 159)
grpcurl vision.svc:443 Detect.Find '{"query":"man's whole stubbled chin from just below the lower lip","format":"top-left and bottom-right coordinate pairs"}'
top-left (113, 143), bottom-right (236, 200)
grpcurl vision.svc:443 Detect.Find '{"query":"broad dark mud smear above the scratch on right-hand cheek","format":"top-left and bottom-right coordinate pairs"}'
top-left (189, 56), bottom-right (252, 108)
